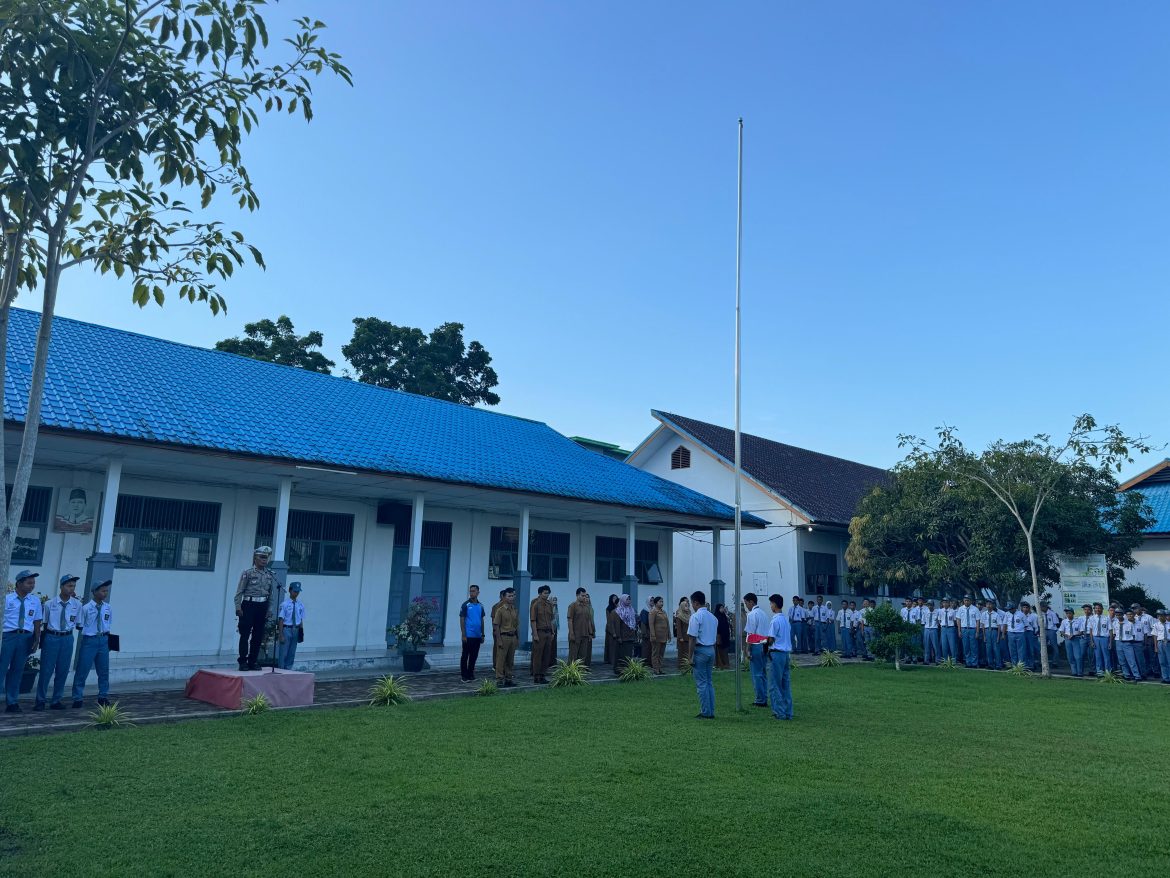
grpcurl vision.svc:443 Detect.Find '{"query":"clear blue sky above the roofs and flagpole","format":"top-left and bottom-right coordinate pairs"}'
top-left (41, 0), bottom-right (1170, 482)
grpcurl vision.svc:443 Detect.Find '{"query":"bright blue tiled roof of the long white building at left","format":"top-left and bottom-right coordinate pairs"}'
top-left (4, 309), bottom-right (764, 524)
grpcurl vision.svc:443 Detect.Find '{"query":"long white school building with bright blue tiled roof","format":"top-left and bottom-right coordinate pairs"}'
top-left (5, 309), bottom-right (768, 684)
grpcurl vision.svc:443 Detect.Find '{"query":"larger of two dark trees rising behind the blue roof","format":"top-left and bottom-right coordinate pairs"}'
top-left (342, 317), bottom-right (500, 405)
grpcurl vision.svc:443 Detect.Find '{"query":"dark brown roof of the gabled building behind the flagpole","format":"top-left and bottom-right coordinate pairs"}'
top-left (651, 411), bottom-right (892, 524)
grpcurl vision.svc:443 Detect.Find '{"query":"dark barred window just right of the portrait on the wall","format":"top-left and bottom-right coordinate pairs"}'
top-left (112, 494), bottom-right (220, 570)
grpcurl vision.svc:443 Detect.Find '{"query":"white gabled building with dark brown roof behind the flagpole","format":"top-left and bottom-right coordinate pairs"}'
top-left (627, 411), bottom-right (889, 608)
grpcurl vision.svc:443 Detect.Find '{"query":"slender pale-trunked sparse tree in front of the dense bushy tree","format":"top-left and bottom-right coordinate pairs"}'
top-left (900, 414), bottom-right (1150, 677)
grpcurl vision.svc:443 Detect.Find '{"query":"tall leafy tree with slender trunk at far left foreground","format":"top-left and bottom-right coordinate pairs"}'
top-left (0, 0), bottom-right (350, 587)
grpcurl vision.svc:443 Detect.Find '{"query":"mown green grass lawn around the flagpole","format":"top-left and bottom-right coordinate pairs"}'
top-left (0, 665), bottom-right (1170, 878)
